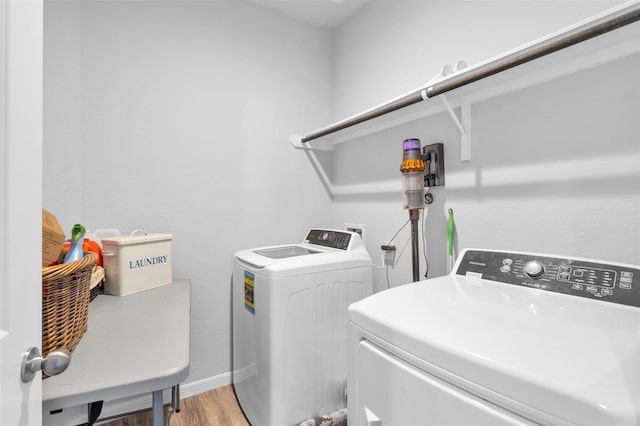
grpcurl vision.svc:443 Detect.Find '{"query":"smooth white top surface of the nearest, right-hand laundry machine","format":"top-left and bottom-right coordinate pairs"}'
top-left (348, 275), bottom-right (640, 425)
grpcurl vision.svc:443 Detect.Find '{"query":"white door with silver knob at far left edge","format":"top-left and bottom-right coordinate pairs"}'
top-left (0, 0), bottom-right (43, 426)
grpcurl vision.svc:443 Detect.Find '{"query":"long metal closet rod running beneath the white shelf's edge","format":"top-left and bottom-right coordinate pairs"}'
top-left (301, 3), bottom-right (640, 143)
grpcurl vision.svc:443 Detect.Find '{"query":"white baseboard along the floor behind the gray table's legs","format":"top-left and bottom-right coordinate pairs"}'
top-left (42, 372), bottom-right (231, 426)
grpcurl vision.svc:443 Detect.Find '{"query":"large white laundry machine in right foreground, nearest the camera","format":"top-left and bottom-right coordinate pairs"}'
top-left (348, 250), bottom-right (640, 426)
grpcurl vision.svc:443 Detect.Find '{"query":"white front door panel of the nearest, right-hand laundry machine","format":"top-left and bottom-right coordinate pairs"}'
top-left (347, 340), bottom-right (536, 426)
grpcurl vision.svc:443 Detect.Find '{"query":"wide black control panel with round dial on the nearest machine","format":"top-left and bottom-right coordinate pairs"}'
top-left (456, 250), bottom-right (640, 307)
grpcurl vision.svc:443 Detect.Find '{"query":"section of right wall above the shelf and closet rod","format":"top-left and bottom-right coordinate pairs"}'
top-left (334, 0), bottom-right (622, 120)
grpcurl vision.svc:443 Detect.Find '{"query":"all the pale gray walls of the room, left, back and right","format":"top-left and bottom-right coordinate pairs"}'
top-left (43, 1), bottom-right (640, 406)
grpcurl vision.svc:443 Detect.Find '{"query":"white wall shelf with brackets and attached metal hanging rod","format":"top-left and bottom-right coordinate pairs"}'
top-left (290, 0), bottom-right (640, 196)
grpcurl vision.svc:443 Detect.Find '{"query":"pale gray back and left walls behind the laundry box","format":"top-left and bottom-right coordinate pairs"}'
top-left (43, 1), bottom-right (331, 392)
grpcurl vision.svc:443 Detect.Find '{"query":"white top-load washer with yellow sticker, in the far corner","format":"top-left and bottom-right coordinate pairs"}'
top-left (232, 229), bottom-right (373, 426)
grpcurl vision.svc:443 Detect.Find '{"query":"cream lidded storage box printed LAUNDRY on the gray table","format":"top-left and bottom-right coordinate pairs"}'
top-left (102, 234), bottom-right (173, 296)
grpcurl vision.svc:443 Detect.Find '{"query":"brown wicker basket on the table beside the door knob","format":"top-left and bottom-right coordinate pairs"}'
top-left (42, 252), bottom-right (98, 357)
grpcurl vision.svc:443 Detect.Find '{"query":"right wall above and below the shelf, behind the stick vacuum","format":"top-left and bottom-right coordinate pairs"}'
top-left (333, 2), bottom-right (640, 288)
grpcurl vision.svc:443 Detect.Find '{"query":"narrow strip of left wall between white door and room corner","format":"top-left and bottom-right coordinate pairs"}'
top-left (43, 1), bottom-right (83, 226)
